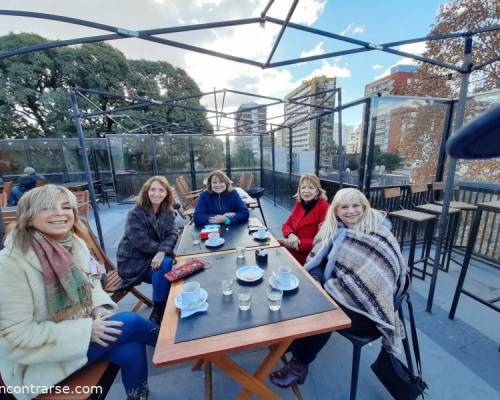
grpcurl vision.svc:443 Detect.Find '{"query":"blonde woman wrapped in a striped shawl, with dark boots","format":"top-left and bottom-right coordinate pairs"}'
top-left (270, 188), bottom-right (406, 388)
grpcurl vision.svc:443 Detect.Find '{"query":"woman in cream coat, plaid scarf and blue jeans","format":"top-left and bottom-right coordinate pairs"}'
top-left (0, 185), bottom-right (159, 399)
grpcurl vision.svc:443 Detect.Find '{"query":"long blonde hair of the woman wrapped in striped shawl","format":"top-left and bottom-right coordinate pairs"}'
top-left (317, 188), bottom-right (386, 242)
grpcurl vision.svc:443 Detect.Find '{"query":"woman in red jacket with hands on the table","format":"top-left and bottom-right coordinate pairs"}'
top-left (281, 174), bottom-right (329, 265)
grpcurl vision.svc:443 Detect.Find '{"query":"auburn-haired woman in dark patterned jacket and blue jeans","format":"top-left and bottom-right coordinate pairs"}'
top-left (117, 176), bottom-right (177, 324)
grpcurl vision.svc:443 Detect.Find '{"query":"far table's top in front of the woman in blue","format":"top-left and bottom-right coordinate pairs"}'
top-left (176, 218), bottom-right (280, 256)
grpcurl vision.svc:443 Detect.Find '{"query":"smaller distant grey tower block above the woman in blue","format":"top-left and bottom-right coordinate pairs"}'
top-left (234, 101), bottom-right (267, 152)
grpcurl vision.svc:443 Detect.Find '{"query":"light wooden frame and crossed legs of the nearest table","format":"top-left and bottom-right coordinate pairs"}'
top-left (153, 248), bottom-right (351, 399)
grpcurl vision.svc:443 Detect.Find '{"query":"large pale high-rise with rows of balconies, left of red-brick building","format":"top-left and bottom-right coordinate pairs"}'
top-left (284, 76), bottom-right (336, 169)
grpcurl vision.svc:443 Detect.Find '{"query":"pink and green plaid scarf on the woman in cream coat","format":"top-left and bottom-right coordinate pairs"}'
top-left (33, 232), bottom-right (92, 322)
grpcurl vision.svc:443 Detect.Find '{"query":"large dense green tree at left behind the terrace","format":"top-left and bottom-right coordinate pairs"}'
top-left (0, 33), bottom-right (212, 138)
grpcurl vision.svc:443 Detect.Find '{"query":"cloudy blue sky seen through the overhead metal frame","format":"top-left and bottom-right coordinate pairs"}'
top-left (0, 0), bottom-right (445, 125)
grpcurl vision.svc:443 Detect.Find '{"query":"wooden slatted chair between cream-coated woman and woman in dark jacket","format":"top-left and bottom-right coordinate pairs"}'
top-left (82, 219), bottom-right (153, 312)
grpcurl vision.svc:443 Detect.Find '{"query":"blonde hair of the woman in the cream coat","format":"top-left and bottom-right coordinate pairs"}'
top-left (11, 185), bottom-right (89, 253)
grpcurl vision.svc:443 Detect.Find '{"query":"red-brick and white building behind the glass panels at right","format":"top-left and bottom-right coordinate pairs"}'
top-left (365, 65), bottom-right (417, 153)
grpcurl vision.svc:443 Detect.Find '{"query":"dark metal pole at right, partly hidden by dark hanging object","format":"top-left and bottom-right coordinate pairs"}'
top-left (425, 37), bottom-right (472, 313)
